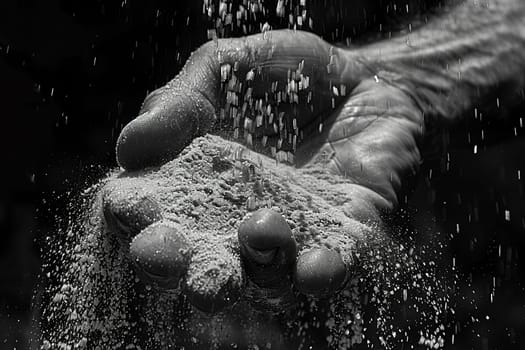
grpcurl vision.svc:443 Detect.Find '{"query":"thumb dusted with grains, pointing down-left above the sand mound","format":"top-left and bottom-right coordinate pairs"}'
top-left (116, 42), bottom-right (219, 170)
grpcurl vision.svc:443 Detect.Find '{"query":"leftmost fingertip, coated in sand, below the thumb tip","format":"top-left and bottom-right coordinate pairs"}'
top-left (102, 180), bottom-right (162, 244)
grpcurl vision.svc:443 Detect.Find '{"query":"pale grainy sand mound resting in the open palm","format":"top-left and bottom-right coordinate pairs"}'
top-left (111, 135), bottom-right (370, 283)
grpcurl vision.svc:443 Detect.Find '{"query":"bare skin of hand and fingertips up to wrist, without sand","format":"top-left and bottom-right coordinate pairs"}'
top-left (104, 30), bottom-right (423, 346)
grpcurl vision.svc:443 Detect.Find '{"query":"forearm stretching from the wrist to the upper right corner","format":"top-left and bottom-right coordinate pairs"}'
top-left (359, 0), bottom-right (525, 121)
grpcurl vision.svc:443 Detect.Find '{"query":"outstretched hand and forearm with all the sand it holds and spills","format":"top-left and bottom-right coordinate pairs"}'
top-left (39, 0), bottom-right (525, 348)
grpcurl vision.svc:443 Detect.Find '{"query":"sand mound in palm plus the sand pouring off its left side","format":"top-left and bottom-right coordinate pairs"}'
top-left (39, 136), bottom-right (367, 349)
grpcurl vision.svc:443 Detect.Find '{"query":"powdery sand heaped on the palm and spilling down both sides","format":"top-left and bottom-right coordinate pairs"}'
top-left (40, 135), bottom-right (448, 349)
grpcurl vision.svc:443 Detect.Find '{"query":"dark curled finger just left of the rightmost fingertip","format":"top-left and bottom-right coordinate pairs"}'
top-left (238, 208), bottom-right (297, 287)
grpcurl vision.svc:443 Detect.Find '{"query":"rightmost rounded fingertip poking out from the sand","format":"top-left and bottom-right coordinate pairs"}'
top-left (293, 248), bottom-right (347, 297)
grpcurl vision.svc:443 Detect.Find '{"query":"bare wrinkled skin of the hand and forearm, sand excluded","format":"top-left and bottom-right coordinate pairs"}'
top-left (100, 0), bottom-right (525, 344)
